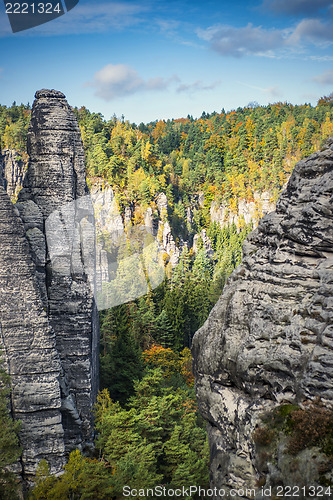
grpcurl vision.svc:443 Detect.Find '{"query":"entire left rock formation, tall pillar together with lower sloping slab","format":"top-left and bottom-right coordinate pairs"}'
top-left (0, 90), bottom-right (98, 480)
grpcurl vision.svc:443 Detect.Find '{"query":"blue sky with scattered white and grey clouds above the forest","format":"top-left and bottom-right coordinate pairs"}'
top-left (0, 0), bottom-right (333, 123)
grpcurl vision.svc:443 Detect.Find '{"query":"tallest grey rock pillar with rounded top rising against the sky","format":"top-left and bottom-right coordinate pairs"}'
top-left (17, 89), bottom-right (98, 449)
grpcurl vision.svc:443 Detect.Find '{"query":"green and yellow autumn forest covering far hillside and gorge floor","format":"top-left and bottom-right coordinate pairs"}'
top-left (0, 94), bottom-right (333, 500)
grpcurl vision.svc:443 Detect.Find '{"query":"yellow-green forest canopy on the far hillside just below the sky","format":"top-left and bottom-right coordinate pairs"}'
top-left (0, 95), bottom-right (333, 213)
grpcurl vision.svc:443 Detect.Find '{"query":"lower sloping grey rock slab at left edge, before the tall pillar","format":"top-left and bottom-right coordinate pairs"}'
top-left (0, 187), bottom-right (65, 478)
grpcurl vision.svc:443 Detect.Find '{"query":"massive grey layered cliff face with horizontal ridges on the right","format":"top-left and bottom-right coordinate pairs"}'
top-left (193, 139), bottom-right (333, 498)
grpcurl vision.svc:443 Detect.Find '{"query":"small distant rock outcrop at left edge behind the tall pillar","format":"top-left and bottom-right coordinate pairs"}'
top-left (0, 149), bottom-right (27, 201)
